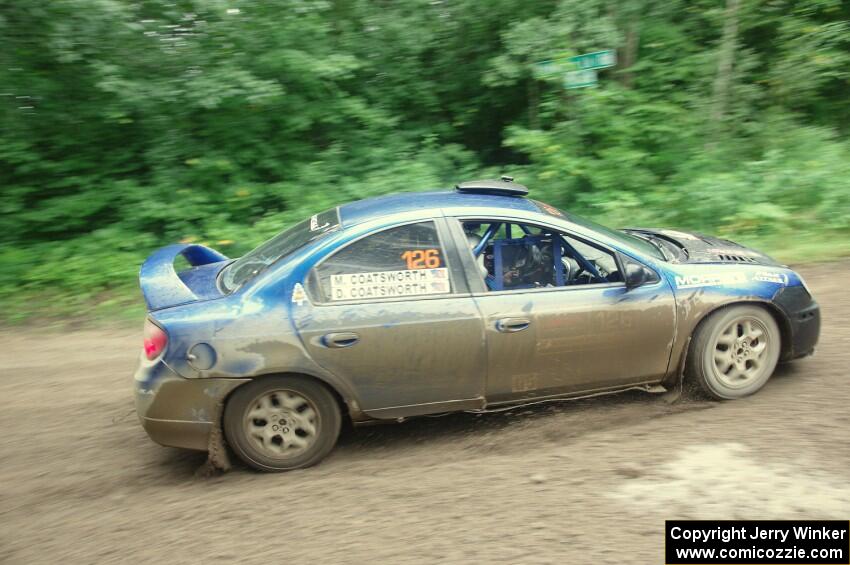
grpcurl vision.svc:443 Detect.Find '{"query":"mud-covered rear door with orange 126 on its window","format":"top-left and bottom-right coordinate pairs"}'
top-left (293, 218), bottom-right (487, 418)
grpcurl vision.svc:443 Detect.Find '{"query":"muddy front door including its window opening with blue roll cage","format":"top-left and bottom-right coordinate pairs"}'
top-left (455, 216), bottom-right (675, 402)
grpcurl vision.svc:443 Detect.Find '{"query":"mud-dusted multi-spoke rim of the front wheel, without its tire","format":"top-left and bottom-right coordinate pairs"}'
top-left (713, 317), bottom-right (771, 388)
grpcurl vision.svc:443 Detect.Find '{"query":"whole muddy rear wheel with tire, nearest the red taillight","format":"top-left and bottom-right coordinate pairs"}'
top-left (224, 375), bottom-right (342, 471)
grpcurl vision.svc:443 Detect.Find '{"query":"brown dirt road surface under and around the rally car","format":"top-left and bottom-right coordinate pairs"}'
top-left (0, 262), bottom-right (850, 564)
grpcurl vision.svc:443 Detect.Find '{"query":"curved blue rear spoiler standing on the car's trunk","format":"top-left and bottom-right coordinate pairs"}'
top-left (139, 243), bottom-right (227, 310)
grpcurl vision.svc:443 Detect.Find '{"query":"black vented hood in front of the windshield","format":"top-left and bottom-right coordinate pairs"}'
top-left (624, 228), bottom-right (781, 266)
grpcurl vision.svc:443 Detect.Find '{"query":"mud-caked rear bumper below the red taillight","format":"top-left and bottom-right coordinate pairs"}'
top-left (134, 357), bottom-right (249, 451)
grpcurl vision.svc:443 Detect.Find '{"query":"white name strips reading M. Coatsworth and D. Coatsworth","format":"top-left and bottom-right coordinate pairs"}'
top-left (331, 268), bottom-right (451, 300)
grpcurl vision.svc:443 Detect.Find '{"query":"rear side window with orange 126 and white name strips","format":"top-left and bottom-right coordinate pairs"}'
top-left (311, 222), bottom-right (452, 302)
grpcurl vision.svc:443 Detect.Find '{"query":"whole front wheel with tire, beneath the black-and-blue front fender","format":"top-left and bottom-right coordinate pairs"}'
top-left (685, 305), bottom-right (782, 400)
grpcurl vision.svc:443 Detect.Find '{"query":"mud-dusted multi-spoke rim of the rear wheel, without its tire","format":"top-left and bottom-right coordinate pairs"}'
top-left (243, 389), bottom-right (319, 459)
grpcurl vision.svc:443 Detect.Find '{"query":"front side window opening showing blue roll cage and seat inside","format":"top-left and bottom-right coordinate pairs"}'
top-left (462, 221), bottom-right (623, 290)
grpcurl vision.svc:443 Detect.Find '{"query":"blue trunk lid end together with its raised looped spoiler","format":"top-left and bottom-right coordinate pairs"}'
top-left (139, 244), bottom-right (228, 311)
